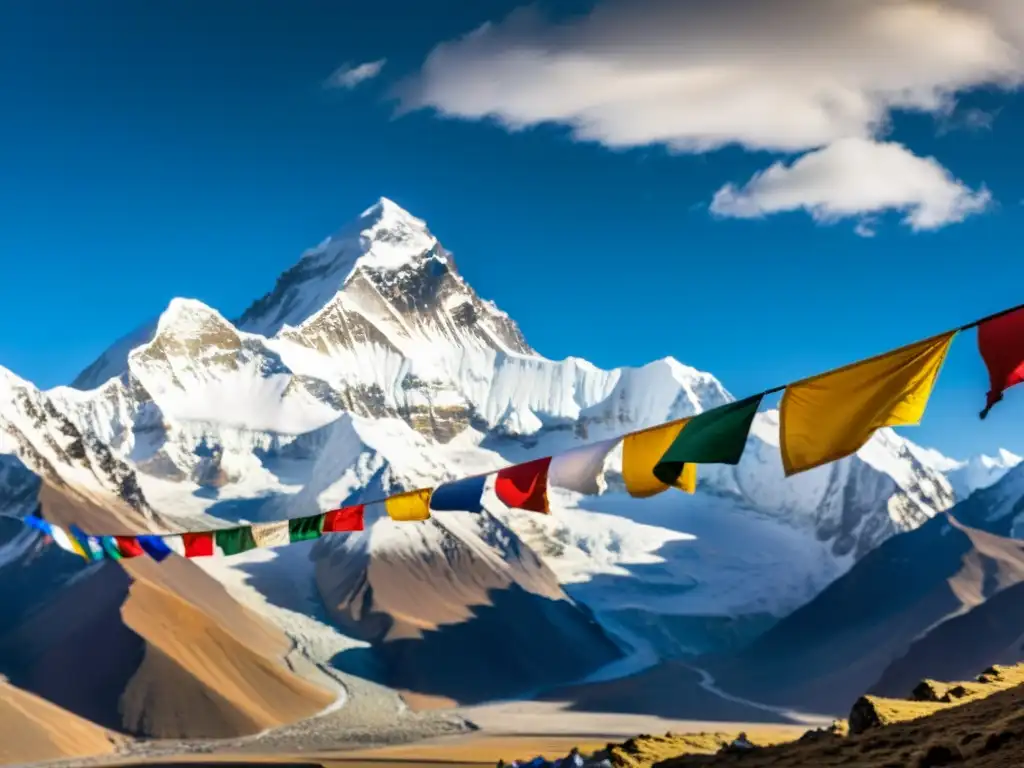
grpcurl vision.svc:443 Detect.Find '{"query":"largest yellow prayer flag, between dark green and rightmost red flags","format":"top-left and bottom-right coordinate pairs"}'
top-left (779, 332), bottom-right (956, 475)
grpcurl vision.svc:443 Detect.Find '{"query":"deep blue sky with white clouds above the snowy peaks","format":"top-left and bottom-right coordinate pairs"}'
top-left (0, 0), bottom-right (1024, 456)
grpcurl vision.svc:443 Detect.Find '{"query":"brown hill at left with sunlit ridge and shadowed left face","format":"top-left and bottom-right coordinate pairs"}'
top-left (0, 488), bottom-right (334, 738)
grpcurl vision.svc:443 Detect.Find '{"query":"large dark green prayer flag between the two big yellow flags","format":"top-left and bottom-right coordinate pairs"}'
top-left (654, 394), bottom-right (762, 485)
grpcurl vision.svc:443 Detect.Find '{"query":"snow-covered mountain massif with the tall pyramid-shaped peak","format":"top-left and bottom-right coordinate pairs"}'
top-left (0, 200), bottom-right (1007, 696)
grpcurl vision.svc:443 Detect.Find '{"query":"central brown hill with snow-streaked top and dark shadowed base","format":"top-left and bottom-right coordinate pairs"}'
top-left (314, 518), bottom-right (621, 709)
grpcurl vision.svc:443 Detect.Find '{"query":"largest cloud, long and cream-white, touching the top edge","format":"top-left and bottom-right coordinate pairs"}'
top-left (395, 0), bottom-right (1024, 152)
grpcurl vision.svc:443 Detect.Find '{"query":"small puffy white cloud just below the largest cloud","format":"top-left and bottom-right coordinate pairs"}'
top-left (711, 138), bottom-right (991, 237)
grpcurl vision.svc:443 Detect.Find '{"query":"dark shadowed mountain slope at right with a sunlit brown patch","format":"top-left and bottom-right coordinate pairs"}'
top-left (705, 467), bottom-right (1024, 712)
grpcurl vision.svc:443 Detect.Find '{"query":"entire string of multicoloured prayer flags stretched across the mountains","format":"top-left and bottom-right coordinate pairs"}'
top-left (26, 306), bottom-right (1024, 561)
